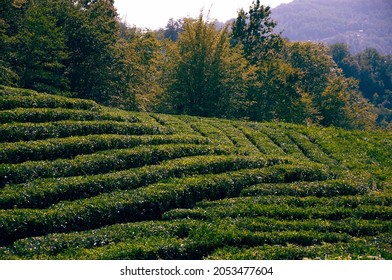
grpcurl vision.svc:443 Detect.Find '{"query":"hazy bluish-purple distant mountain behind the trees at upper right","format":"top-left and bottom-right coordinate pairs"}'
top-left (272, 0), bottom-right (392, 54)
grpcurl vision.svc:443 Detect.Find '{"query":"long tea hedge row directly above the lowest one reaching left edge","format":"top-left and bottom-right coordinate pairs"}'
top-left (0, 156), bottom-right (294, 209)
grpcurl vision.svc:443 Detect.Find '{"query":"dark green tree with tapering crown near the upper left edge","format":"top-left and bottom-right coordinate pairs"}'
top-left (11, 1), bottom-right (69, 93)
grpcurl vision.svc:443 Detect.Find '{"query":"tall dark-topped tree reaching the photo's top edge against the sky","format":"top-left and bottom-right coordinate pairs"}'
top-left (231, 0), bottom-right (306, 122)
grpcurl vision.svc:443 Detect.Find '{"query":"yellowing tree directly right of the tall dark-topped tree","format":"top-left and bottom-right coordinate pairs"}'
top-left (285, 42), bottom-right (375, 129)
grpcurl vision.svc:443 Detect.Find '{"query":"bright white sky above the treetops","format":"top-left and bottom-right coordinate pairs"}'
top-left (114, 0), bottom-right (293, 30)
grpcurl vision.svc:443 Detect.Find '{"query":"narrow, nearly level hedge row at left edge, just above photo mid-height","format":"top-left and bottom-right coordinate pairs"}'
top-left (0, 121), bottom-right (165, 142)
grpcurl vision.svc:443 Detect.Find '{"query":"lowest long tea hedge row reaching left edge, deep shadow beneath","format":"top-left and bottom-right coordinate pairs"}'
top-left (0, 162), bottom-right (329, 244)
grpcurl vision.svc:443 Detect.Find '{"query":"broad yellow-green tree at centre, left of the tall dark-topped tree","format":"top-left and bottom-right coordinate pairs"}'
top-left (169, 15), bottom-right (250, 117)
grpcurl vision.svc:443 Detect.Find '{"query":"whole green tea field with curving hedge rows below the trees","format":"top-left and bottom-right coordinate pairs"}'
top-left (0, 87), bottom-right (392, 259)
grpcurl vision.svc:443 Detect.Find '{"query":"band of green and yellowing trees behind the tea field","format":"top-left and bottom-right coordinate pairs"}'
top-left (0, 0), bottom-right (391, 129)
